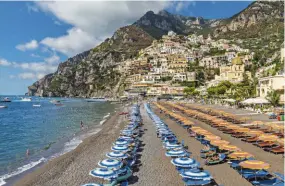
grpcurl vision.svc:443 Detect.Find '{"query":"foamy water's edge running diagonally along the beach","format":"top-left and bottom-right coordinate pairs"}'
top-left (0, 105), bottom-right (124, 186)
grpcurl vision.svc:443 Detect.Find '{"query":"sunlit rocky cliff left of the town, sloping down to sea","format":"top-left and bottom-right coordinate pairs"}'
top-left (28, 26), bottom-right (153, 97)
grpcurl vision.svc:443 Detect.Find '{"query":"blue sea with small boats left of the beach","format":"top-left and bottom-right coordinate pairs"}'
top-left (0, 96), bottom-right (120, 186)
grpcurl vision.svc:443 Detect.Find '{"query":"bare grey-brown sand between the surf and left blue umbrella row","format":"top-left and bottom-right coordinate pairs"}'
top-left (15, 106), bottom-right (127, 186)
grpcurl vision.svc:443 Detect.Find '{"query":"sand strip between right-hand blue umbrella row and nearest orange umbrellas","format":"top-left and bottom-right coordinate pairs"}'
top-left (152, 106), bottom-right (251, 186)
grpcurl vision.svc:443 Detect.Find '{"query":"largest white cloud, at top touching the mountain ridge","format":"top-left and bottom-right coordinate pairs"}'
top-left (36, 1), bottom-right (172, 56)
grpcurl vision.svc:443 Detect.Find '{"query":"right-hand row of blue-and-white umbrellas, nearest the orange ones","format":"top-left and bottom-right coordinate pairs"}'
top-left (145, 104), bottom-right (214, 186)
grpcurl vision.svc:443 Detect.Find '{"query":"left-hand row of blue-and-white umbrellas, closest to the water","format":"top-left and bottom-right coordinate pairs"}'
top-left (84, 105), bottom-right (142, 186)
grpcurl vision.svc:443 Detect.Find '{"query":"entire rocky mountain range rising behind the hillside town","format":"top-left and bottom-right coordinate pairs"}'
top-left (28, 1), bottom-right (284, 97)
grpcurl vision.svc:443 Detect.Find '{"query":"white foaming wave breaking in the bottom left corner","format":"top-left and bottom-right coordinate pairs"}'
top-left (0, 158), bottom-right (47, 186)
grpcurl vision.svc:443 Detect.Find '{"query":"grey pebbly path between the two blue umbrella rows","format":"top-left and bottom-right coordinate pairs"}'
top-left (130, 106), bottom-right (184, 186)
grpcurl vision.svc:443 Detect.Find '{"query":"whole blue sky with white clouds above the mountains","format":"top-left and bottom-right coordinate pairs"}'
top-left (0, 1), bottom-right (251, 95)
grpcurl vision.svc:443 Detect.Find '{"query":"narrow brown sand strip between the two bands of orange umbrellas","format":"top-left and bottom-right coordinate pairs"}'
top-left (159, 105), bottom-right (284, 173)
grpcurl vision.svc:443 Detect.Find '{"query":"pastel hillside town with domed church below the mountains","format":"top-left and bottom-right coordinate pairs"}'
top-left (110, 31), bottom-right (285, 106)
